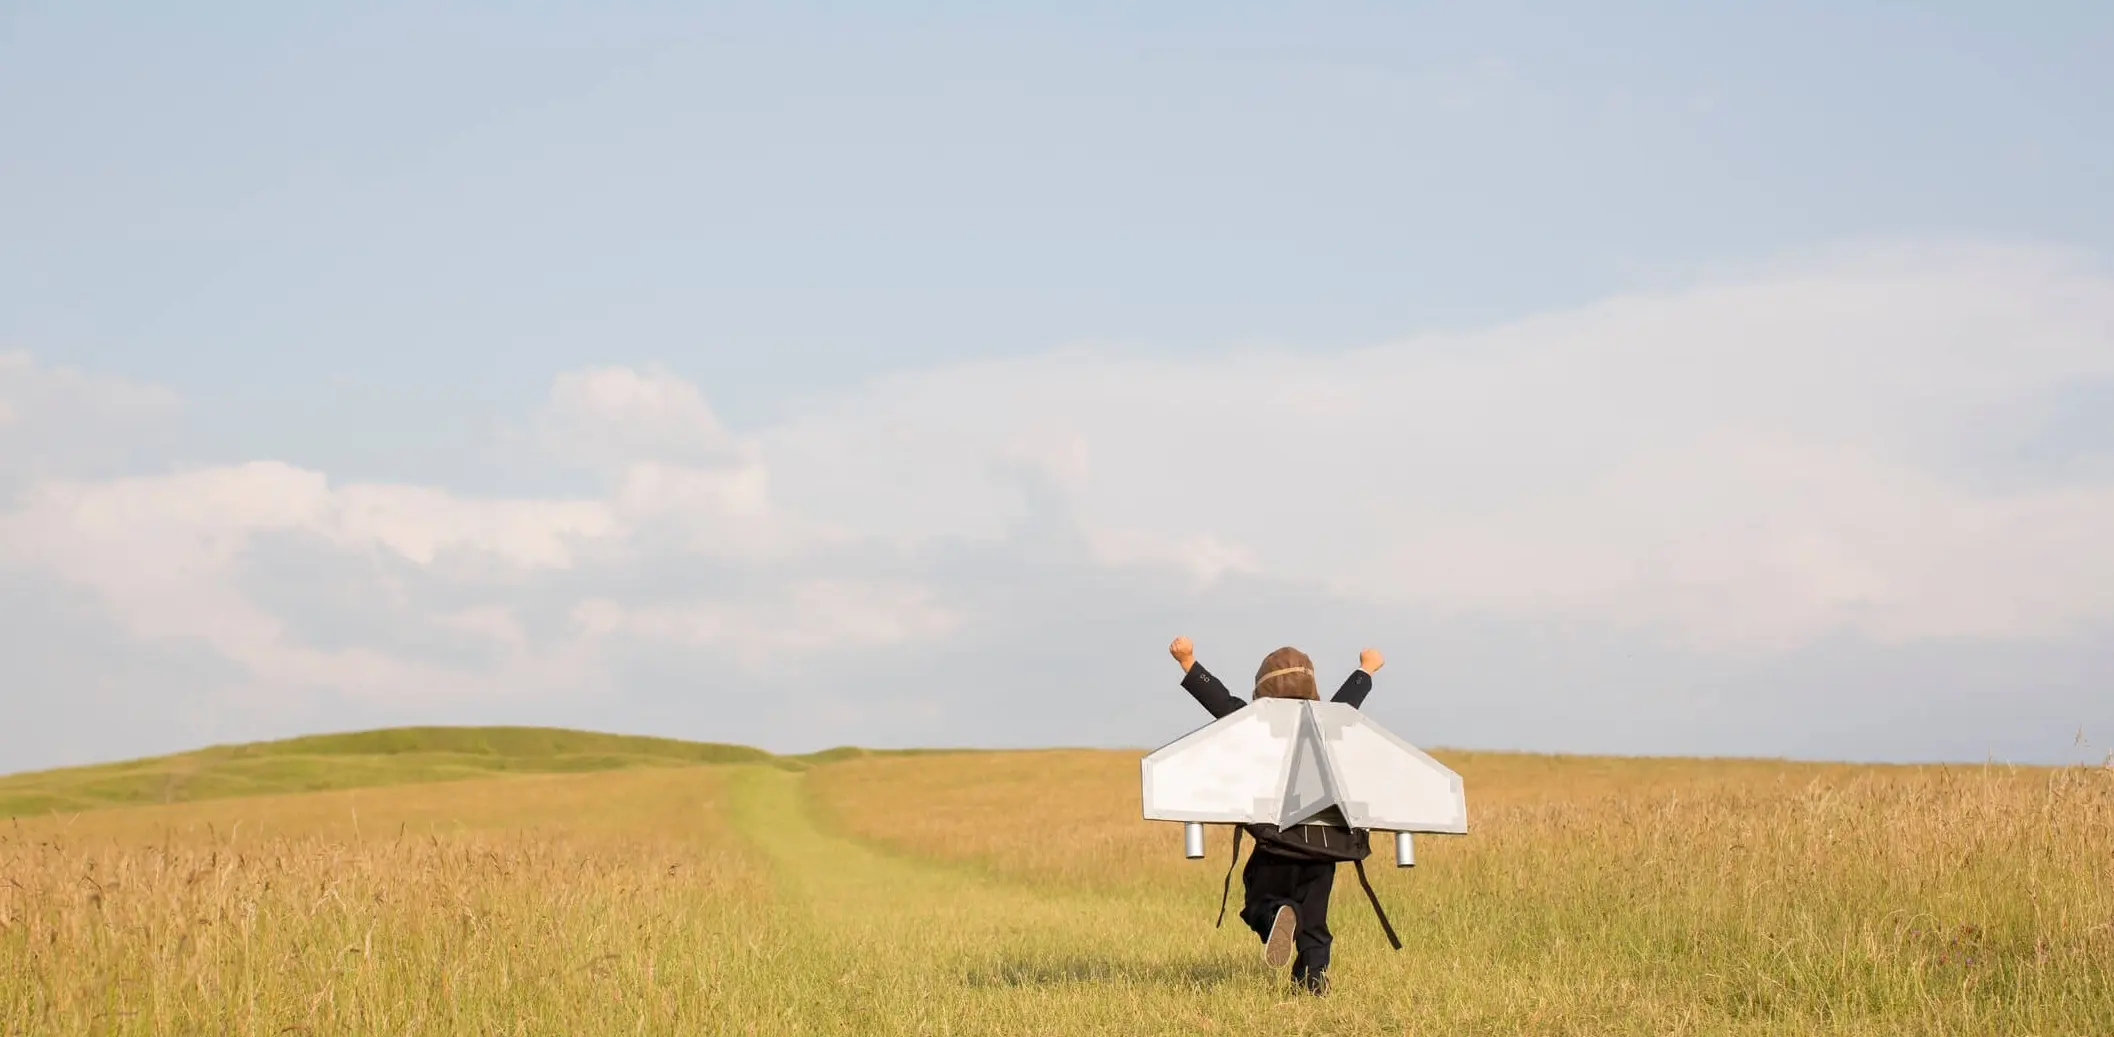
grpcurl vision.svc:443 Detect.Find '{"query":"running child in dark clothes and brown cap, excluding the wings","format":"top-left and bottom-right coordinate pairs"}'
top-left (1167, 638), bottom-right (1383, 995)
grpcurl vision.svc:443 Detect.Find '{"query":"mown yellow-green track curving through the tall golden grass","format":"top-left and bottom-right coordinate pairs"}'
top-left (727, 767), bottom-right (1283, 1033)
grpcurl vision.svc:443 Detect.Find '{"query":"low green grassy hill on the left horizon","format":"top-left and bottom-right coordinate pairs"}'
top-left (0, 727), bottom-right (909, 817)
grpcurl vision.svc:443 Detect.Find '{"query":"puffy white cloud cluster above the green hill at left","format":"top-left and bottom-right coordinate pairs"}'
top-left (0, 369), bottom-right (953, 701)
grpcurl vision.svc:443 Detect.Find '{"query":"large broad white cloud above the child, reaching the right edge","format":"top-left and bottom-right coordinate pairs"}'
top-left (761, 249), bottom-right (2114, 651)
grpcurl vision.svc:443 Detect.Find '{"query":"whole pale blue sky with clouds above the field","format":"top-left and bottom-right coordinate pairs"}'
top-left (0, 0), bottom-right (2114, 771)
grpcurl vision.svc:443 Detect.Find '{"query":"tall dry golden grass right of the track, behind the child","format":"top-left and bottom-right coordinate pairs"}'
top-left (810, 752), bottom-right (2114, 1033)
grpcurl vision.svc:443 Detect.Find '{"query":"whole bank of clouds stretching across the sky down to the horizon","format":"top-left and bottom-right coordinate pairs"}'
top-left (0, 247), bottom-right (2114, 769)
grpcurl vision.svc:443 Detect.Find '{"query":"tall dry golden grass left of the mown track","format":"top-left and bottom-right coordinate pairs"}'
top-left (0, 769), bottom-right (765, 1035)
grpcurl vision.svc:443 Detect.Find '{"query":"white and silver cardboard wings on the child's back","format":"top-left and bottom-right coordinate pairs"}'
top-left (1139, 699), bottom-right (1467, 834)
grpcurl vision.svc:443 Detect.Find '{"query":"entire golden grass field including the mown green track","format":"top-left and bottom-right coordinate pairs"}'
top-left (0, 733), bottom-right (2114, 1035)
